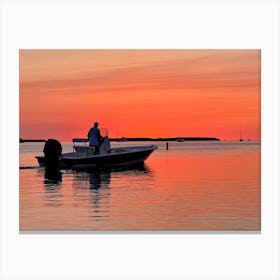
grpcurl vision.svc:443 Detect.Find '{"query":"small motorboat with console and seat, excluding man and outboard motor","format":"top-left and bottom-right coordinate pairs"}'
top-left (36, 136), bottom-right (157, 169)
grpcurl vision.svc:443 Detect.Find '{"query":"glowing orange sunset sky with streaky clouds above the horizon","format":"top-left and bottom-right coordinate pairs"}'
top-left (19, 50), bottom-right (261, 141)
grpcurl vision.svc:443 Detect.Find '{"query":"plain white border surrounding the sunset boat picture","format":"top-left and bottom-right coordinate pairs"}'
top-left (0, 0), bottom-right (280, 280)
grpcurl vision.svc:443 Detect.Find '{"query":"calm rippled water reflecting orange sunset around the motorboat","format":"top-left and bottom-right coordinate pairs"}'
top-left (19, 141), bottom-right (261, 231)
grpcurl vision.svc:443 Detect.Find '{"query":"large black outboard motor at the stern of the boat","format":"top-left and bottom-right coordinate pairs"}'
top-left (43, 139), bottom-right (62, 171)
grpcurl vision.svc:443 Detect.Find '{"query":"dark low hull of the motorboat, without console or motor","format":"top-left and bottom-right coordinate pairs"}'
top-left (36, 145), bottom-right (157, 169)
